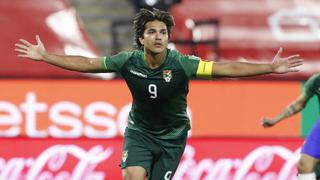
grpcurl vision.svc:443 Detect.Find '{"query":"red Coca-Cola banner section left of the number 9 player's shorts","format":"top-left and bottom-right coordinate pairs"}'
top-left (0, 138), bottom-right (122, 180)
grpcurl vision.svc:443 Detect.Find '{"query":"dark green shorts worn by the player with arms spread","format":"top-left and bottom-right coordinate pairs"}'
top-left (121, 128), bottom-right (187, 180)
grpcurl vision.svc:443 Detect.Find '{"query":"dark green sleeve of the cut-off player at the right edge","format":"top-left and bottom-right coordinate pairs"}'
top-left (303, 73), bottom-right (320, 112)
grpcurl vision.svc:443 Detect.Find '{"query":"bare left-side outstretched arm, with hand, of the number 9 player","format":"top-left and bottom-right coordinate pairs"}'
top-left (15, 35), bottom-right (104, 72)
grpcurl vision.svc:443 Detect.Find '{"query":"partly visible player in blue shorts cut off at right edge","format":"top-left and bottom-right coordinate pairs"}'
top-left (262, 73), bottom-right (320, 180)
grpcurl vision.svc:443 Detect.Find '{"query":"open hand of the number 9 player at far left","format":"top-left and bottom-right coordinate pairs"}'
top-left (15, 35), bottom-right (46, 61)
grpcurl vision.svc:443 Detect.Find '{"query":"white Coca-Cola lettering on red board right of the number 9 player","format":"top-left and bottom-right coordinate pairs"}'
top-left (173, 145), bottom-right (300, 180)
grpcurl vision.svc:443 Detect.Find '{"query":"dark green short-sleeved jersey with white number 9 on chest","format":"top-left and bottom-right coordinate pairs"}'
top-left (103, 49), bottom-right (200, 139)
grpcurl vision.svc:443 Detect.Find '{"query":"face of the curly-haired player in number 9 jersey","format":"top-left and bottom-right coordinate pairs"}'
top-left (139, 20), bottom-right (169, 54)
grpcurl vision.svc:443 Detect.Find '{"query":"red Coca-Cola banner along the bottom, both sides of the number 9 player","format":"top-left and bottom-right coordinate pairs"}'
top-left (0, 138), bottom-right (302, 180)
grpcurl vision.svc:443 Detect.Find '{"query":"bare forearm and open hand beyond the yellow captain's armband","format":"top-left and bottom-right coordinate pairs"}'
top-left (212, 48), bottom-right (303, 77)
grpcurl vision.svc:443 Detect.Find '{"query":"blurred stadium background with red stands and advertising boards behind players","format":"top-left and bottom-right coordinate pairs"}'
top-left (0, 0), bottom-right (320, 180)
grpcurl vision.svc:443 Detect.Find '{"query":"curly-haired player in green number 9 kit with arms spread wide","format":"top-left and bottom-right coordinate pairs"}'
top-left (16, 9), bottom-right (302, 180)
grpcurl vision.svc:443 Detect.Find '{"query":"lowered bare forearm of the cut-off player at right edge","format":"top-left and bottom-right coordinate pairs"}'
top-left (261, 93), bottom-right (308, 127)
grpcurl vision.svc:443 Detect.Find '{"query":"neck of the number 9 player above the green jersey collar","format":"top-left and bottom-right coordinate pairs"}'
top-left (144, 50), bottom-right (167, 69)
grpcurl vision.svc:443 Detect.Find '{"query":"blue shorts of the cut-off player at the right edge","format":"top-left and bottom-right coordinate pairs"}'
top-left (301, 118), bottom-right (320, 159)
